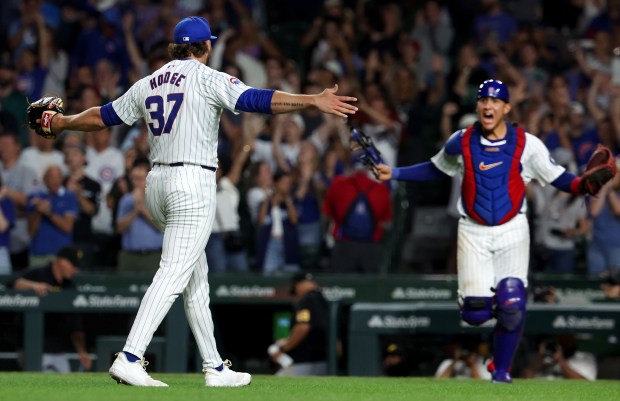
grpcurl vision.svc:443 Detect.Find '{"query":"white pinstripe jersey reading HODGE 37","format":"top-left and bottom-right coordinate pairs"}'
top-left (112, 58), bottom-right (250, 167)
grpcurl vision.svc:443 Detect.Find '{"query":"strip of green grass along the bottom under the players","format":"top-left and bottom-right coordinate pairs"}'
top-left (0, 373), bottom-right (620, 401)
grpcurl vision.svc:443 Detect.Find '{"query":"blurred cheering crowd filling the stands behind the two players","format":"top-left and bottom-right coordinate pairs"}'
top-left (0, 0), bottom-right (620, 274)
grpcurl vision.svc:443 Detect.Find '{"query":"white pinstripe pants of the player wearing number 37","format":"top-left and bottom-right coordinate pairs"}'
top-left (123, 164), bottom-right (222, 367)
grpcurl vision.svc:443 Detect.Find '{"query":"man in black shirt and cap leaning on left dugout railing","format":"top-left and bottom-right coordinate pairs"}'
top-left (10, 246), bottom-right (92, 373)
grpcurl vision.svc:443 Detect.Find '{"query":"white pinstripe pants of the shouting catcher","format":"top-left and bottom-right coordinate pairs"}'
top-left (457, 214), bottom-right (530, 298)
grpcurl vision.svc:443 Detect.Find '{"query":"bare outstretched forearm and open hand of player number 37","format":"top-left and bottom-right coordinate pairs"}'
top-left (271, 85), bottom-right (357, 117)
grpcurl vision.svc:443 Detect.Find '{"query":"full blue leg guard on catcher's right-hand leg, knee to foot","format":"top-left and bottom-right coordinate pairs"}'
top-left (493, 277), bottom-right (527, 376)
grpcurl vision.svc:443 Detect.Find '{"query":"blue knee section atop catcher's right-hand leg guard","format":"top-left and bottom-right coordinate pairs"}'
top-left (495, 277), bottom-right (527, 332)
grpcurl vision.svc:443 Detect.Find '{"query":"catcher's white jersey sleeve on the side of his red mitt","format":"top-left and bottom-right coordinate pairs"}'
top-left (523, 134), bottom-right (565, 186)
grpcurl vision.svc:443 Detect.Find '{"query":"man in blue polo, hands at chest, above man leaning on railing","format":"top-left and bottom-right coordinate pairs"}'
top-left (26, 166), bottom-right (79, 267)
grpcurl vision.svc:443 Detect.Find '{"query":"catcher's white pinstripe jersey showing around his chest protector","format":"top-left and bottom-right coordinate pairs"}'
top-left (431, 130), bottom-right (565, 216)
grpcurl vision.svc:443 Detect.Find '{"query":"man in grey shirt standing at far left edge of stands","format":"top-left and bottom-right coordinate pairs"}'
top-left (0, 132), bottom-right (40, 270)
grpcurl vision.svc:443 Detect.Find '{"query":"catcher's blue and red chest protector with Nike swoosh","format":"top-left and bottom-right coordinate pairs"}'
top-left (461, 125), bottom-right (525, 226)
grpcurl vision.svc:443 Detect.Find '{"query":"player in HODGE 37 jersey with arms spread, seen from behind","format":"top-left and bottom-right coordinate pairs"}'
top-left (28, 17), bottom-right (357, 387)
